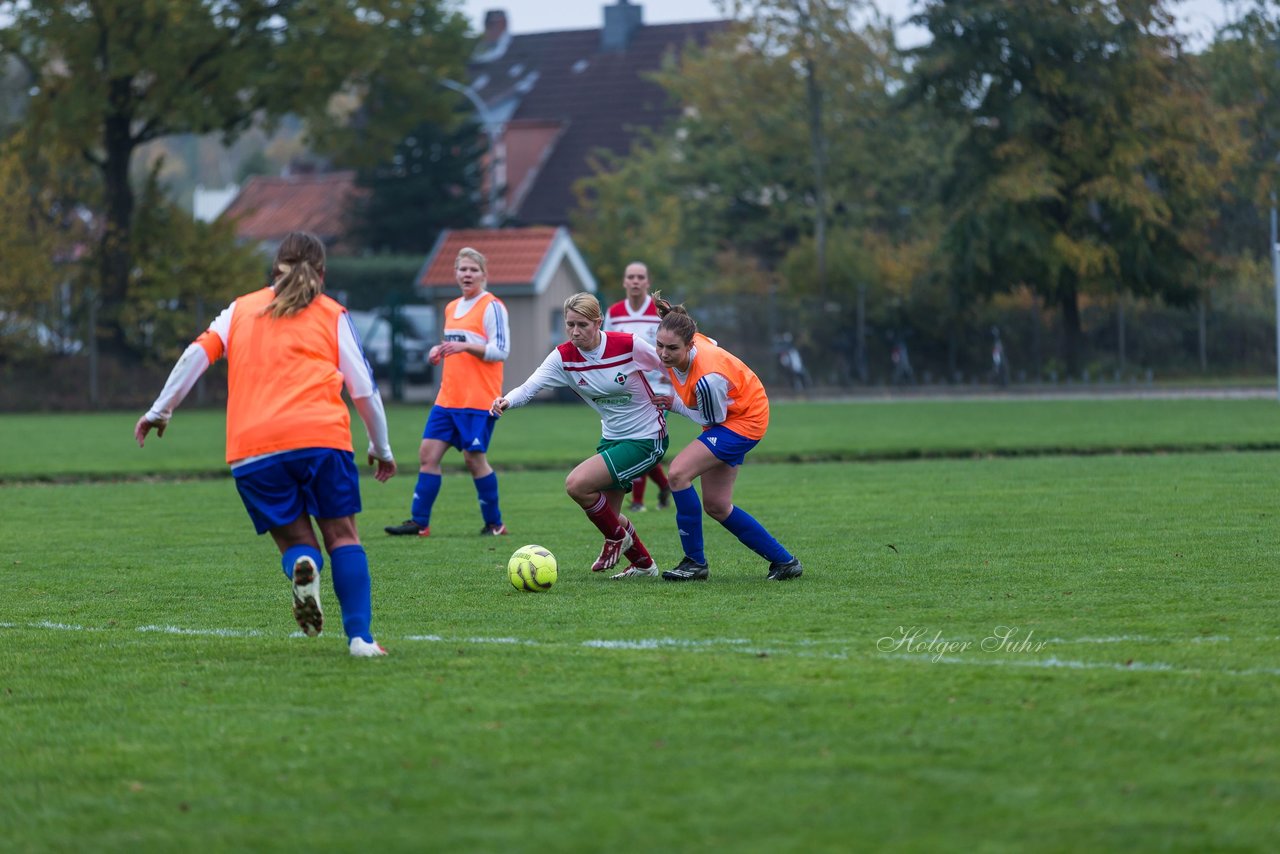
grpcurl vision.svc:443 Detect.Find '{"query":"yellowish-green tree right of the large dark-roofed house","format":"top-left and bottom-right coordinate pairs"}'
top-left (580, 0), bottom-right (946, 378)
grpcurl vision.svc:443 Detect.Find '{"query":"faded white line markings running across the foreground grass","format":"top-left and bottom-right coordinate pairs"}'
top-left (0, 620), bottom-right (1280, 676)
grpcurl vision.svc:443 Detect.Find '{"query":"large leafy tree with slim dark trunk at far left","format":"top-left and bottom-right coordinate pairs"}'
top-left (0, 0), bottom-right (468, 351)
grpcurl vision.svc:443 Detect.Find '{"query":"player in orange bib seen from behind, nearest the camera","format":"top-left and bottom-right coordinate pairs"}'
top-left (133, 232), bottom-right (396, 658)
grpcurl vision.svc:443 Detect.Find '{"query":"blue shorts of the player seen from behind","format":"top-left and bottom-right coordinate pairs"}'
top-left (233, 448), bottom-right (360, 534)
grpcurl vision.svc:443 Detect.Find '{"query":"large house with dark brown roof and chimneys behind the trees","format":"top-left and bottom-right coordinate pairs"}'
top-left (467, 0), bottom-right (732, 225)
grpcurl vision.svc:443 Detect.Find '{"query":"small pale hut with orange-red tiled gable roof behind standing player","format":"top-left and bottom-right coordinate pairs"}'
top-left (416, 227), bottom-right (599, 391)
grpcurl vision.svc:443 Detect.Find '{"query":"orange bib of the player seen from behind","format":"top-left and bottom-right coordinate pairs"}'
top-left (196, 288), bottom-right (352, 462)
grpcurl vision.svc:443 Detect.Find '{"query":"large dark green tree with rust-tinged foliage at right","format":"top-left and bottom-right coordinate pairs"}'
top-left (911, 0), bottom-right (1235, 373)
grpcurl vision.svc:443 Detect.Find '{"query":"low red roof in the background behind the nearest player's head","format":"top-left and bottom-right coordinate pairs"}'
top-left (223, 170), bottom-right (367, 255)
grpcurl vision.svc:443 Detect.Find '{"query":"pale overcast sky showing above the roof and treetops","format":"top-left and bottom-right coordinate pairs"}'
top-left (462, 0), bottom-right (1231, 47)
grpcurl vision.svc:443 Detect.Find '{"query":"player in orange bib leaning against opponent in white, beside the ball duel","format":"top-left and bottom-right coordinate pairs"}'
top-left (653, 293), bottom-right (804, 581)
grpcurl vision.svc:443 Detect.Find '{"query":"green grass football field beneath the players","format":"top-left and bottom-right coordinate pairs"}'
top-left (0, 401), bottom-right (1280, 851)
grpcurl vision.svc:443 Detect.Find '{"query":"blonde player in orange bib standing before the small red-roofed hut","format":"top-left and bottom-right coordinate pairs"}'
top-left (384, 247), bottom-right (511, 536)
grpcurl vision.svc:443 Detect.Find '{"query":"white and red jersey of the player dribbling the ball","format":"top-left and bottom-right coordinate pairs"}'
top-left (504, 332), bottom-right (667, 439)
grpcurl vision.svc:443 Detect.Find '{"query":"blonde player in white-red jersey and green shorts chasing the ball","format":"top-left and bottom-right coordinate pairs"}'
top-left (490, 293), bottom-right (668, 579)
